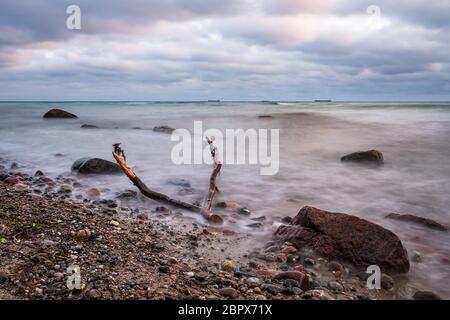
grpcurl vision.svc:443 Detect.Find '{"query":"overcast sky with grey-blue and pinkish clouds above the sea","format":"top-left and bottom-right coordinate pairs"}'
top-left (0, 0), bottom-right (450, 100)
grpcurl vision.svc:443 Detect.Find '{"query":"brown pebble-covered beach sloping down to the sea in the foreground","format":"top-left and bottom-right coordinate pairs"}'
top-left (0, 158), bottom-right (407, 300)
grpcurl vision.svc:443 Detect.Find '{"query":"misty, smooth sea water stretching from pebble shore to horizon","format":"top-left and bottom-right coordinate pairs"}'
top-left (0, 102), bottom-right (450, 297)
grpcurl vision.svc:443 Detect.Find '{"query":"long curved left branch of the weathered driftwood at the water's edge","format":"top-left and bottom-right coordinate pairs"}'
top-left (112, 143), bottom-right (223, 223)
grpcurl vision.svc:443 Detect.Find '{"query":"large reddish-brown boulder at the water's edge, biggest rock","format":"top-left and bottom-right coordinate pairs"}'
top-left (275, 207), bottom-right (409, 273)
